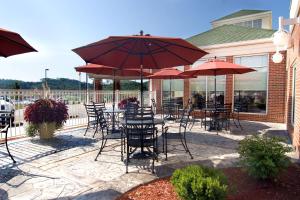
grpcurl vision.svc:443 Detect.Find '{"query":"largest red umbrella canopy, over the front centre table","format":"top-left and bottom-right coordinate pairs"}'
top-left (73, 32), bottom-right (207, 69)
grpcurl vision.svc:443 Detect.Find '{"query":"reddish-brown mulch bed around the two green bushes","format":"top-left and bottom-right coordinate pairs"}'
top-left (118, 165), bottom-right (300, 200)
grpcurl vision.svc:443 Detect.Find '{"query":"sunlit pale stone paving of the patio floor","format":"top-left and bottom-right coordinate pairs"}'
top-left (0, 121), bottom-right (295, 200)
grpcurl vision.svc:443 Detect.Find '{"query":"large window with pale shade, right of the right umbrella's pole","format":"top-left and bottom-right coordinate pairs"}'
top-left (234, 55), bottom-right (268, 113)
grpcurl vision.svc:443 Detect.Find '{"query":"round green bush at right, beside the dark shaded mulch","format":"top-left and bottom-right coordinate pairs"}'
top-left (238, 136), bottom-right (292, 180)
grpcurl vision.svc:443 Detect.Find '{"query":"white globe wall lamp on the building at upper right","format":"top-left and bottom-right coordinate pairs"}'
top-left (272, 17), bottom-right (300, 63)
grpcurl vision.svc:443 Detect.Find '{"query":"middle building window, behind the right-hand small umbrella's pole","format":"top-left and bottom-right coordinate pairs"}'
top-left (190, 60), bottom-right (226, 109)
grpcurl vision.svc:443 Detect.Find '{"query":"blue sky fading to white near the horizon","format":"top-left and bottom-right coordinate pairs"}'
top-left (0, 0), bottom-right (290, 81)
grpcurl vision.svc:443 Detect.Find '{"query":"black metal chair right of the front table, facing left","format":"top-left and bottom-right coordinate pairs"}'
top-left (163, 108), bottom-right (193, 160)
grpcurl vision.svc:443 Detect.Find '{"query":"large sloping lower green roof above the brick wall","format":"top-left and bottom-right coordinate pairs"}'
top-left (186, 24), bottom-right (275, 46)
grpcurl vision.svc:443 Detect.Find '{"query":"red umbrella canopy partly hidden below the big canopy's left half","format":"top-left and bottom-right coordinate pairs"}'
top-left (75, 64), bottom-right (151, 77)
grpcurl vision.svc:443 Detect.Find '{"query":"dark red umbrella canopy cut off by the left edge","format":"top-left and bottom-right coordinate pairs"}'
top-left (0, 28), bottom-right (37, 57)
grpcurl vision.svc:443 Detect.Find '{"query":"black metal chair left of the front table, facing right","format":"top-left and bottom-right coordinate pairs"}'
top-left (95, 109), bottom-right (125, 161)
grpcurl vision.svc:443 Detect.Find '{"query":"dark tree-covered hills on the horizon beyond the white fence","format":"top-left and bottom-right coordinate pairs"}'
top-left (0, 78), bottom-right (148, 90)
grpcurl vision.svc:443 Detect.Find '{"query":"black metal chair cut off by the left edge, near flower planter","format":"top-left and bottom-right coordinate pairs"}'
top-left (0, 112), bottom-right (16, 163)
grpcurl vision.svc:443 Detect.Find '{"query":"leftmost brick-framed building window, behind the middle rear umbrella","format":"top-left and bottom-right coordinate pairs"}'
top-left (162, 66), bottom-right (184, 106)
